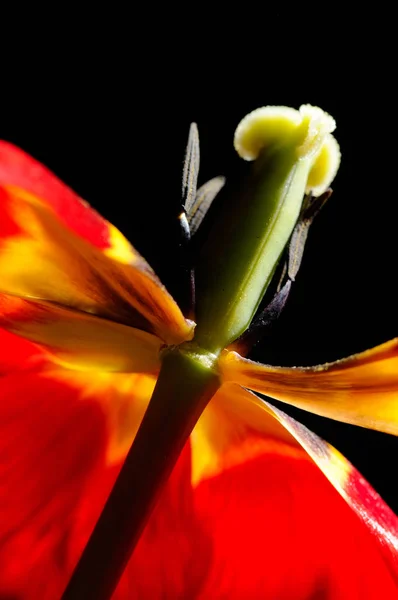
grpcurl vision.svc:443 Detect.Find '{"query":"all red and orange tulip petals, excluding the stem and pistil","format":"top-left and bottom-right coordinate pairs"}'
top-left (0, 105), bottom-right (398, 600)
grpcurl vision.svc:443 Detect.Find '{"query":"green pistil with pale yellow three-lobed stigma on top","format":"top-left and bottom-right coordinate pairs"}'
top-left (195, 105), bottom-right (340, 354)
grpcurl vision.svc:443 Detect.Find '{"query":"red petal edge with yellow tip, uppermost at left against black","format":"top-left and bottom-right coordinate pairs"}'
top-left (0, 141), bottom-right (137, 262)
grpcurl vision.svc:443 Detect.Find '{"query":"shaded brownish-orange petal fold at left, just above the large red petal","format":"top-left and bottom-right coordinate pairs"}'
top-left (0, 292), bottom-right (161, 373)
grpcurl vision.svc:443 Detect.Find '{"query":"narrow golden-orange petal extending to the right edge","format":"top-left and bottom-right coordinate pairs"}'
top-left (220, 338), bottom-right (398, 435)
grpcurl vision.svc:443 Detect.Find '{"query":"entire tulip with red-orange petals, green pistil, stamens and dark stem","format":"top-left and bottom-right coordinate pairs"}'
top-left (0, 105), bottom-right (398, 600)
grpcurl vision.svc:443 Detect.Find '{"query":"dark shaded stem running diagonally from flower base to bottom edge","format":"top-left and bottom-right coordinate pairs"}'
top-left (62, 345), bottom-right (220, 600)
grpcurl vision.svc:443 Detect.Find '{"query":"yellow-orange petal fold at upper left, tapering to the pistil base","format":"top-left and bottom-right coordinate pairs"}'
top-left (0, 188), bottom-right (192, 343)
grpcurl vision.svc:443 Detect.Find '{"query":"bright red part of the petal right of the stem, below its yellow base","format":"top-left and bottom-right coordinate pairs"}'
top-left (113, 422), bottom-right (398, 600)
